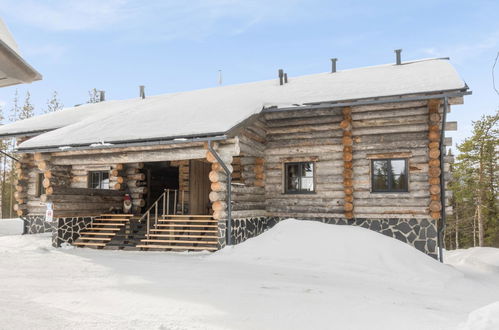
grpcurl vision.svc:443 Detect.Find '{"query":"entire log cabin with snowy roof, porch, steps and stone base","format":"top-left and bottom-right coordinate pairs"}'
top-left (0, 58), bottom-right (470, 258)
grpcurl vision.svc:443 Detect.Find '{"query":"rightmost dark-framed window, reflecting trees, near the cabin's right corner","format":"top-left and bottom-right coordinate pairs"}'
top-left (371, 159), bottom-right (408, 192)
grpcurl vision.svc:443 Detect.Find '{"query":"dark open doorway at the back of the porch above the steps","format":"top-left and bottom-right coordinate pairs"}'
top-left (144, 162), bottom-right (179, 208)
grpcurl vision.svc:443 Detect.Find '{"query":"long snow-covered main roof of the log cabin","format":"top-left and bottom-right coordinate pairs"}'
top-left (0, 59), bottom-right (466, 149)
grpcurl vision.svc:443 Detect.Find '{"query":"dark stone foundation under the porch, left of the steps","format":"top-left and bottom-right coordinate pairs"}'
top-left (21, 215), bottom-right (92, 247)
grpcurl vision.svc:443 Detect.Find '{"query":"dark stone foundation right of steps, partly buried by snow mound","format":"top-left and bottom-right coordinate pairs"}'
top-left (223, 217), bottom-right (437, 259)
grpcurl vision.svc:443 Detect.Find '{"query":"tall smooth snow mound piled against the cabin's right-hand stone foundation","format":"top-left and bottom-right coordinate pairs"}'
top-left (213, 219), bottom-right (458, 279)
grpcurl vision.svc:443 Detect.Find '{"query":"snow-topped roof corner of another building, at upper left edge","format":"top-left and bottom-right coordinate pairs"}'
top-left (0, 19), bottom-right (42, 87)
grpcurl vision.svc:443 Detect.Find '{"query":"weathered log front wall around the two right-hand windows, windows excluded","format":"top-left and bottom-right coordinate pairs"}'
top-left (263, 101), bottom-right (451, 219)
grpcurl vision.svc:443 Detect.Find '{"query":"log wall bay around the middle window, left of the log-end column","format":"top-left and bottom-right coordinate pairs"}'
top-left (264, 108), bottom-right (345, 219)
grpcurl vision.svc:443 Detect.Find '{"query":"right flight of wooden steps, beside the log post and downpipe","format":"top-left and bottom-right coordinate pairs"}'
top-left (137, 214), bottom-right (218, 251)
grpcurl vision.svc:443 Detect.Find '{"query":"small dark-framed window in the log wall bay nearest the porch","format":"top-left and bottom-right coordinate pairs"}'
top-left (284, 162), bottom-right (315, 194)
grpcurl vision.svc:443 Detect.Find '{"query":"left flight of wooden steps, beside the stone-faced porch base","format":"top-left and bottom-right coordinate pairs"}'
top-left (73, 214), bottom-right (133, 249)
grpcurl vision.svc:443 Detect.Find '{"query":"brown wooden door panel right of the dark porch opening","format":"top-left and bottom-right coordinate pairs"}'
top-left (189, 160), bottom-right (211, 214)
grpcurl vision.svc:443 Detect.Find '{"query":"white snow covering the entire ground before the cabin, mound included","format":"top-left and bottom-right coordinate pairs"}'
top-left (0, 220), bottom-right (499, 330)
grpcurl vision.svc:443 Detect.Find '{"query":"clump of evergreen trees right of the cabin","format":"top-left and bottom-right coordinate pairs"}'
top-left (447, 111), bottom-right (499, 247)
